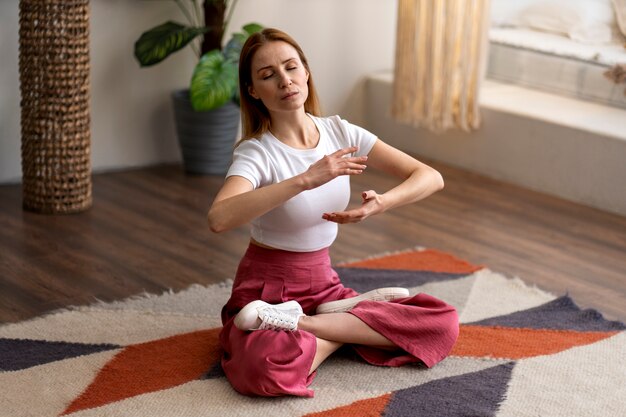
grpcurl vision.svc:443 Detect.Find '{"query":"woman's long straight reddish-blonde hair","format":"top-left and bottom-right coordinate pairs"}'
top-left (239, 28), bottom-right (321, 141)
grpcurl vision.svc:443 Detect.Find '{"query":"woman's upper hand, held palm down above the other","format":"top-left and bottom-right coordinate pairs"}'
top-left (300, 146), bottom-right (367, 190)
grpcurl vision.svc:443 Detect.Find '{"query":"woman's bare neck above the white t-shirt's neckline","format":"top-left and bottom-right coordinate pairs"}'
top-left (270, 110), bottom-right (319, 149)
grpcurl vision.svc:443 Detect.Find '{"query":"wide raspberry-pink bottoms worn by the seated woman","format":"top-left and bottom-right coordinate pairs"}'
top-left (220, 245), bottom-right (459, 397)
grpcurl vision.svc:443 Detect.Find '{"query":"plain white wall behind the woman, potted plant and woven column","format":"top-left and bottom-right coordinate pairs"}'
top-left (0, 0), bottom-right (396, 183)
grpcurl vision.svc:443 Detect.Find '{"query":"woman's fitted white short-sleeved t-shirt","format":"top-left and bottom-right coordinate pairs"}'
top-left (226, 115), bottom-right (376, 252)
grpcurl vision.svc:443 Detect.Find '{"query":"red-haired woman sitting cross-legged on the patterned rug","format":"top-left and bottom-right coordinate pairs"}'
top-left (208, 29), bottom-right (458, 397)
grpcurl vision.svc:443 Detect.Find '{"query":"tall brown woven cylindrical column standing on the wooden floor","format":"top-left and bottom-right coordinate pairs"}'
top-left (19, 0), bottom-right (92, 213)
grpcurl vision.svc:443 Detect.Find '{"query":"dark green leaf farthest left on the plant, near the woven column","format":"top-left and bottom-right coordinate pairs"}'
top-left (135, 21), bottom-right (208, 67)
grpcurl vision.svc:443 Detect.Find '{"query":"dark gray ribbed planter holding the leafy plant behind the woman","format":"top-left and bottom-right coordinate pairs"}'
top-left (172, 90), bottom-right (240, 175)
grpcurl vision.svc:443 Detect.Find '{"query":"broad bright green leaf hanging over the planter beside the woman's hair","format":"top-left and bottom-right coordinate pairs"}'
top-left (189, 49), bottom-right (238, 111)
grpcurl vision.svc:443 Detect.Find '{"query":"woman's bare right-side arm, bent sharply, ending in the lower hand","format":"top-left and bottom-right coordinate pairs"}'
top-left (322, 140), bottom-right (444, 223)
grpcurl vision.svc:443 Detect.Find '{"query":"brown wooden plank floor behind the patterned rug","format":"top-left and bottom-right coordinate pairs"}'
top-left (0, 163), bottom-right (626, 322)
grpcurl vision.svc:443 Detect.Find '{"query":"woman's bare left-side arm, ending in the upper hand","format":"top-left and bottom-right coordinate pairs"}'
top-left (207, 147), bottom-right (367, 233)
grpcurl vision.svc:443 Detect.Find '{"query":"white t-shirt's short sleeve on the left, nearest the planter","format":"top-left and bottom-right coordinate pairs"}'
top-left (226, 139), bottom-right (271, 189)
